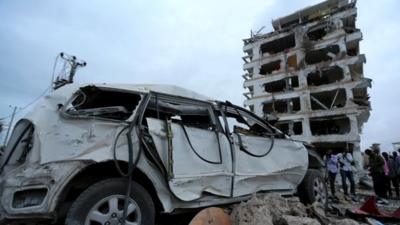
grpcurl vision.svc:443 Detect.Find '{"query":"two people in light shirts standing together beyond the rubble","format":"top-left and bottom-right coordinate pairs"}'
top-left (325, 149), bottom-right (356, 200)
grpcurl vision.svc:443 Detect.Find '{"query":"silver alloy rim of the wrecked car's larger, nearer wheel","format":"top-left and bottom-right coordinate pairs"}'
top-left (85, 195), bottom-right (142, 225)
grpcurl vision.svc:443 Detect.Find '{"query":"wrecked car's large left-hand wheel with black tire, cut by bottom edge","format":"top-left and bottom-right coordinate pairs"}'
top-left (65, 178), bottom-right (155, 225)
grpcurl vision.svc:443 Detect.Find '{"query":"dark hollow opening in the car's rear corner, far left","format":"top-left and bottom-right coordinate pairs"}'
top-left (1, 119), bottom-right (34, 170)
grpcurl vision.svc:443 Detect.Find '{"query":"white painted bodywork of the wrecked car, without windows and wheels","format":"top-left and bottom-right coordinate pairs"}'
top-left (0, 84), bottom-right (308, 223)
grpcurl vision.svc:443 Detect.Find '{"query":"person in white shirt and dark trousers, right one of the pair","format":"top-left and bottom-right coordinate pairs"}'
top-left (338, 148), bottom-right (356, 197)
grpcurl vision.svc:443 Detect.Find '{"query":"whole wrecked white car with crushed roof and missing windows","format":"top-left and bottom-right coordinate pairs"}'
top-left (0, 84), bottom-right (327, 225)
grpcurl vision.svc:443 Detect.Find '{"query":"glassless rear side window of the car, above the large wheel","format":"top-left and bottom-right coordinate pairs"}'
top-left (66, 86), bottom-right (141, 120)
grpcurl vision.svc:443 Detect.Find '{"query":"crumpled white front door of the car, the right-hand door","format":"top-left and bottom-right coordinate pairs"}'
top-left (220, 105), bottom-right (308, 196)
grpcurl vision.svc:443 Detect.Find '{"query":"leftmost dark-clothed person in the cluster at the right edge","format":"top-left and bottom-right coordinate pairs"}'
top-left (365, 148), bottom-right (387, 201)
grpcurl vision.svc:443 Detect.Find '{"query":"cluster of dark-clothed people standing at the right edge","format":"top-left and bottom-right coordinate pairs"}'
top-left (364, 146), bottom-right (400, 203)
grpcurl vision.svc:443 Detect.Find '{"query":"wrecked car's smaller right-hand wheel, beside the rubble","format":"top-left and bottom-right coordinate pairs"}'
top-left (298, 169), bottom-right (328, 207)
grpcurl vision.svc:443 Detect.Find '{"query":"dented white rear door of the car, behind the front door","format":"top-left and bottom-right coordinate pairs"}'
top-left (145, 95), bottom-right (233, 201)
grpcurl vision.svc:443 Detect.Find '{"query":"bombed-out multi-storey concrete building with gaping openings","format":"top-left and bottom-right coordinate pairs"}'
top-left (243, 0), bottom-right (371, 165)
